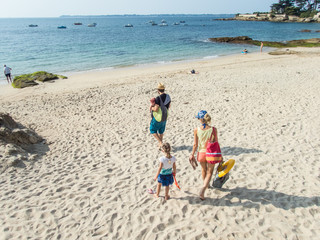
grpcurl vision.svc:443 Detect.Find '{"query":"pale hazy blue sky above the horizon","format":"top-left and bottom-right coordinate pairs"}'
top-left (0, 0), bottom-right (278, 18)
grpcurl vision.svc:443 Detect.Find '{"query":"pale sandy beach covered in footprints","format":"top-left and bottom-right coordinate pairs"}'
top-left (0, 48), bottom-right (320, 240)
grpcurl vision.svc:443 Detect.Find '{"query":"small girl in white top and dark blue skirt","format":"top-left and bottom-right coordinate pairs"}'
top-left (154, 143), bottom-right (176, 200)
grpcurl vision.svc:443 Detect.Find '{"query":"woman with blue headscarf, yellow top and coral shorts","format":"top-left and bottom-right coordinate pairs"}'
top-left (189, 110), bottom-right (222, 200)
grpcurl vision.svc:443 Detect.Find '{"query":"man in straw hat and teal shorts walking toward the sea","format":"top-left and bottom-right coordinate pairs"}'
top-left (150, 83), bottom-right (171, 147)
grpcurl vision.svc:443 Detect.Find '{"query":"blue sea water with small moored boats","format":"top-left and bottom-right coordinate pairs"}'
top-left (0, 15), bottom-right (320, 82)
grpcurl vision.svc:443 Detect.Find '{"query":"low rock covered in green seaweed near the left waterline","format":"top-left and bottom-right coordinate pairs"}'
top-left (12, 71), bottom-right (67, 88)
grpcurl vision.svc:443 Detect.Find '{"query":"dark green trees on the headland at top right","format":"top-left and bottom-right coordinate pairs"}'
top-left (271, 0), bottom-right (320, 18)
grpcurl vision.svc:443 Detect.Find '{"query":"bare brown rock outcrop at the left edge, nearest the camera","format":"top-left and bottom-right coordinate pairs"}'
top-left (0, 113), bottom-right (43, 173)
